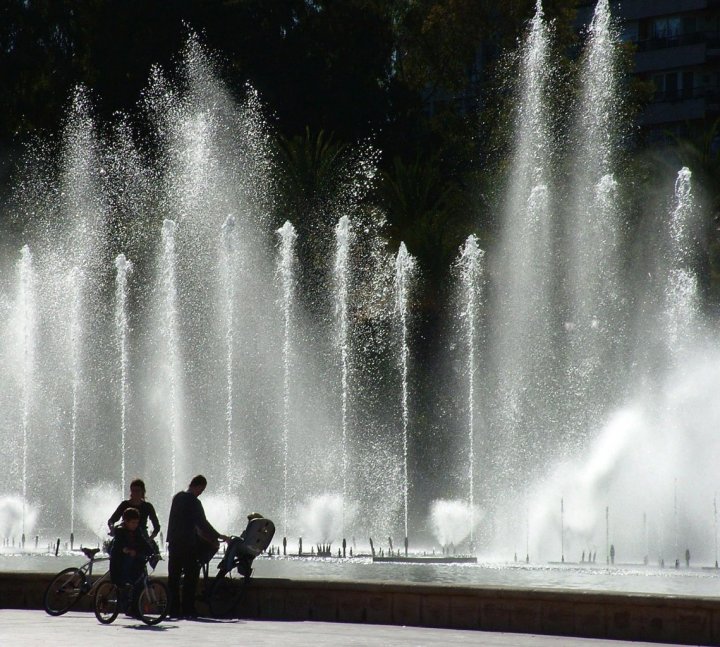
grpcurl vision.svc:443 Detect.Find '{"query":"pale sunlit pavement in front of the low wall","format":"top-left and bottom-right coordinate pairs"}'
top-left (0, 609), bottom-right (680, 647)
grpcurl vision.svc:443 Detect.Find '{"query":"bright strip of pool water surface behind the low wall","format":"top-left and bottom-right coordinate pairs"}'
top-left (0, 555), bottom-right (720, 598)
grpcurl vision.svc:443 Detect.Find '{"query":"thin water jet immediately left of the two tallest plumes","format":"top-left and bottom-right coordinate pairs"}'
top-left (456, 234), bottom-right (485, 548)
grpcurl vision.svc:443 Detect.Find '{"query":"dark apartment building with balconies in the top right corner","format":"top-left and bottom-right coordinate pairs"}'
top-left (579, 0), bottom-right (720, 134)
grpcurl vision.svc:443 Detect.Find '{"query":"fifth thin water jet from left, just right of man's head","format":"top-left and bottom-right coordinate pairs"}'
top-left (222, 215), bottom-right (238, 524)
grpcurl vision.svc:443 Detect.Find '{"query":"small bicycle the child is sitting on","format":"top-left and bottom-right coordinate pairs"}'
top-left (94, 555), bottom-right (168, 625)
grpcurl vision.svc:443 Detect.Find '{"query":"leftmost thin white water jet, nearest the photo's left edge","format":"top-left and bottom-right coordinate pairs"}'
top-left (18, 245), bottom-right (35, 541)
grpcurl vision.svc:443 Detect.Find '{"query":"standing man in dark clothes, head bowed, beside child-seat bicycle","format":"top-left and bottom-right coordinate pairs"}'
top-left (167, 475), bottom-right (227, 618)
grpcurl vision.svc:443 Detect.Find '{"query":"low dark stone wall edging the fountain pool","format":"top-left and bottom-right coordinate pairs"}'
top-left (5, 573), bottom-right (720, 645)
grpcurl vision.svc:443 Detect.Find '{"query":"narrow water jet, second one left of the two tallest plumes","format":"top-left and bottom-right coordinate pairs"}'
top-left (395, 243), bottom-right (416, 551)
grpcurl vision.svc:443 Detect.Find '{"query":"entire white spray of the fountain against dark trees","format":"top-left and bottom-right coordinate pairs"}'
top-left (0, 1), bottom-right (720, 592)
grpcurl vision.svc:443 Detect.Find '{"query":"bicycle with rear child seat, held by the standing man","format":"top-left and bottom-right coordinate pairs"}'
top-left (203, 515), bottom-right (275, 618)
